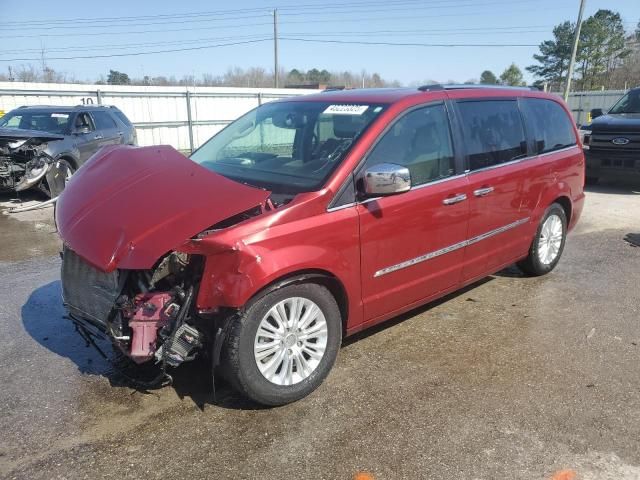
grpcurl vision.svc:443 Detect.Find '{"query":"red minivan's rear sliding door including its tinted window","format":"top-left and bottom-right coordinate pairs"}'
top-left (456, 98), bottom-right (530, 281)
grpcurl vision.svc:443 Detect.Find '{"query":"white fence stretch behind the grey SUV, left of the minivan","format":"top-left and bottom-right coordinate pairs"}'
top-left (0, 82), bottom-right (317, 150)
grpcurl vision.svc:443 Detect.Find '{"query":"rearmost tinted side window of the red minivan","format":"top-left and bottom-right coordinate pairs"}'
top-left (522, 98), bottom-right (577, 154)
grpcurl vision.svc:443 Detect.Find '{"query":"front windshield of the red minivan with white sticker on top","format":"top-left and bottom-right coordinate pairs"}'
top-left (191, 102), bottom-right (385, 194)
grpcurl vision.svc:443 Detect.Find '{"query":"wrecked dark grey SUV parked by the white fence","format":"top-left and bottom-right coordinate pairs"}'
top-left (0, 105), bottom-right (137, 197)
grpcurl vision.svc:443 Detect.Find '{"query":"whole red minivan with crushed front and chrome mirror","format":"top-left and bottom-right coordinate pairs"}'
top-left (56, 85), bottom-right (585, 405)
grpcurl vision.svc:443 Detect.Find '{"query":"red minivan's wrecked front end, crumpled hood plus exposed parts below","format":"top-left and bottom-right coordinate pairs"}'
top-left (56, 146), bottom-right (274, 386)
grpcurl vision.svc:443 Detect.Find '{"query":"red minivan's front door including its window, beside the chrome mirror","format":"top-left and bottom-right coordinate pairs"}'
top-left (357, 103), bottom-right (469, 322)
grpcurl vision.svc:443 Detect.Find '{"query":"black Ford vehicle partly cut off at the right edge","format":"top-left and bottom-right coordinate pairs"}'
top-left (581, 87), bottom-right (640, 183)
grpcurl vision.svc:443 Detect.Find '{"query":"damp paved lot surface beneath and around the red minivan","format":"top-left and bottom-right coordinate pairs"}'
top-left (0, 184), bottom-right (640, 479)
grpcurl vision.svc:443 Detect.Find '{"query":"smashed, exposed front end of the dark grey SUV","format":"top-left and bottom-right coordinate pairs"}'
top-left (0, 132), bottom-right (63, 195)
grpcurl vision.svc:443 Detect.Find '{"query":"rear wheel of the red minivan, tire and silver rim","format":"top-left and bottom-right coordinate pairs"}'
top-left (518, 203), bottom-right (567, 276)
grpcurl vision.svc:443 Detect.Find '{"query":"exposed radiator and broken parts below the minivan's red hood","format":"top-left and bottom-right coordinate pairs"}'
top-left (62, 248), bottom-right (207, 371)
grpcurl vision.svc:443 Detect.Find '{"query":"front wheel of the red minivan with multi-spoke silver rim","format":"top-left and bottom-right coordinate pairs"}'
top-left (221, 283), bottom-right (342, 406)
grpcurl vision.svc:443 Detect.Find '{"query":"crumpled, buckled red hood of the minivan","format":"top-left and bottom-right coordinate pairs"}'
top-left (56, 145), bottom-right (270, 272)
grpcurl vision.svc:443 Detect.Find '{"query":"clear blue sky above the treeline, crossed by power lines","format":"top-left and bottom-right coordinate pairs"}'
top-left (0, 0), bottom-right (640, 85)
